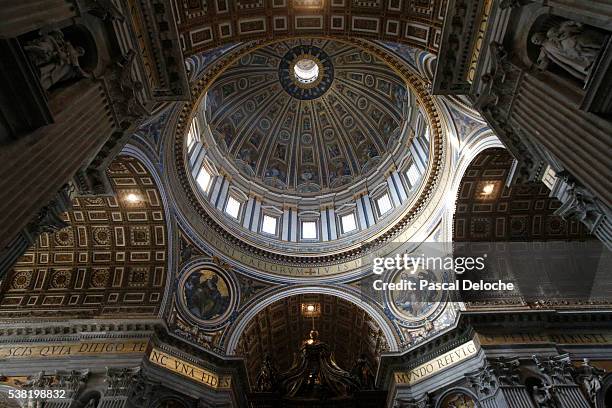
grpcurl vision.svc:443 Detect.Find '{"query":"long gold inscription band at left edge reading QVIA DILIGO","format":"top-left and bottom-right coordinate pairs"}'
top-left (0, 341), bottom-right (148, 359)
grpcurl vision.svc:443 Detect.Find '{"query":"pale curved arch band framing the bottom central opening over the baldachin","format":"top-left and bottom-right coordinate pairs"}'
top-left (225, 285), bottom-right (399, 355)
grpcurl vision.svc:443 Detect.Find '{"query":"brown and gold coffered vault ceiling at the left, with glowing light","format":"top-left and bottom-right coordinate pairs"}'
top-left (0, 156), bottom-right (167, 318)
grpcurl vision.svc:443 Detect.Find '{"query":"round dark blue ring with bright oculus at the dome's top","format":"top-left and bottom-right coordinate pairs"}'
top-left (278, 45), bottom-right (334, 100)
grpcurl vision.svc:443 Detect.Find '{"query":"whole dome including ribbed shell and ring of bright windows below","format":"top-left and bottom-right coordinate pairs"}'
top-left (177, 38), bottom-right (441, 264)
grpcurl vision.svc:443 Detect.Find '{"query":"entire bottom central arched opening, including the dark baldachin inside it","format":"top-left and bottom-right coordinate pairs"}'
top-left (238, 293), bottom-right (386, 408)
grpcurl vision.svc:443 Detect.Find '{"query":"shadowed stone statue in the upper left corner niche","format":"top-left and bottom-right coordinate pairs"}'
top-left (24, 30), bottom-right (90, 90)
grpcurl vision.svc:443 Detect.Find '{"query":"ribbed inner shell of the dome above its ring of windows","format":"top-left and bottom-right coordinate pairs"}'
top-left (205, 39), bottom-right (409, 196)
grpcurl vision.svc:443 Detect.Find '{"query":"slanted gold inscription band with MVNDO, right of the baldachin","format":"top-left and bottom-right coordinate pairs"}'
top-left (393, 340), bottom-right (478, 385)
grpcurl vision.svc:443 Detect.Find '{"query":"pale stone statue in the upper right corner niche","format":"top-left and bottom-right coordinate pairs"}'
top-left (531, 20), bottom-right (606, 82)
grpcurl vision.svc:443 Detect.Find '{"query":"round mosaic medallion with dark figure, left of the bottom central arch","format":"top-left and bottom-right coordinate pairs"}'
top-left (179, 264), bottom-right (236, 326)
